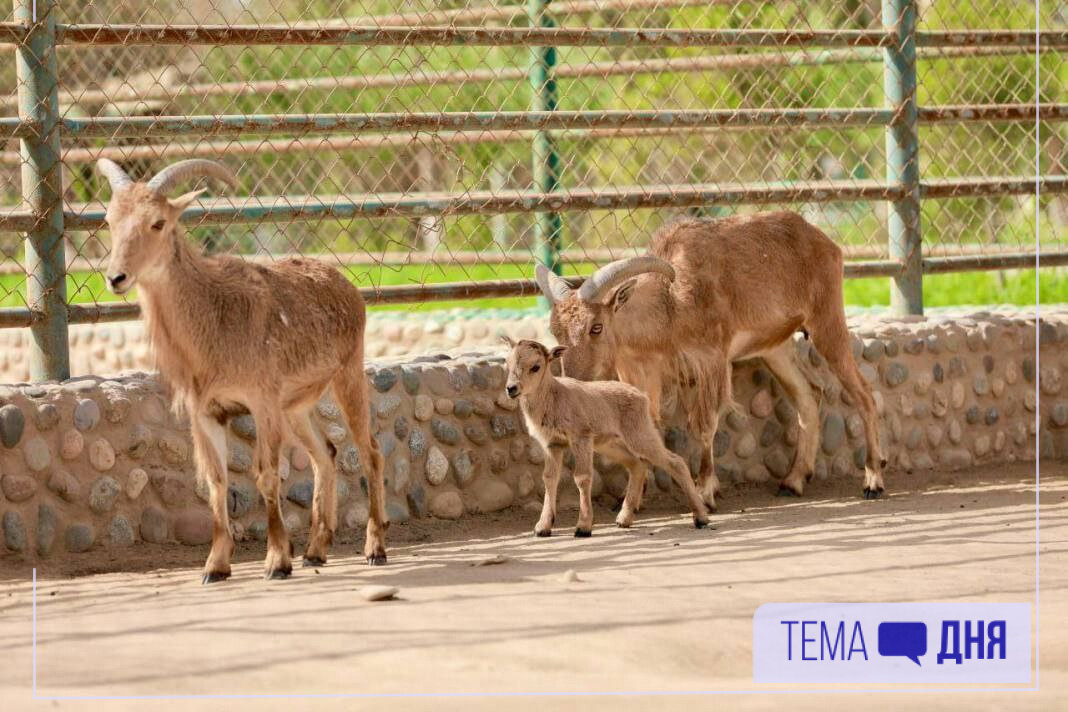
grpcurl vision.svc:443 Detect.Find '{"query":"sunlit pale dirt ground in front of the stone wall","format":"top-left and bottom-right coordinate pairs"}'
top-left (0, 463), bottom-right (1068, 711)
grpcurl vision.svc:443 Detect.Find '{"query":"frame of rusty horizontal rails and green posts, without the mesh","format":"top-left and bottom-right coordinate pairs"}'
top-left (0, 0), bottom-right (1068, 380)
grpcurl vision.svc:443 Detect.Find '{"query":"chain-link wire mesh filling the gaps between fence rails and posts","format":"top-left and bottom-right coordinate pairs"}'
top-left (0, 0), bottom-right (1068, 320)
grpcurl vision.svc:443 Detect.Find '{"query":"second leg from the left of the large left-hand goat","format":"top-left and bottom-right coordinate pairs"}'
top-left (252, 407), bottom-right (293, 579)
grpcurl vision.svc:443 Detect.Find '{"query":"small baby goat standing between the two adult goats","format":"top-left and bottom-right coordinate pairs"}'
top-left (504, 336), bottom-right (708, 537)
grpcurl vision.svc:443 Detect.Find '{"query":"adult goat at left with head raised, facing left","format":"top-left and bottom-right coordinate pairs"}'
top-left (97, 159), bottom-right (388, 583)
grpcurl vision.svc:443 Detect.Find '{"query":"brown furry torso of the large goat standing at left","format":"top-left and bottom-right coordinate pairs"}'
top-left (142, 242), bottom-right (366, 403)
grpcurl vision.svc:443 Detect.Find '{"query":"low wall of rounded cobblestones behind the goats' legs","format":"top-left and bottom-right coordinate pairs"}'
top-left (0, 311), bottom-right (1068, 557)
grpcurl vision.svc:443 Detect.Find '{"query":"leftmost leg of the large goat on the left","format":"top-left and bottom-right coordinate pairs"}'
top-left (188, 406), bottom-right (234, 584)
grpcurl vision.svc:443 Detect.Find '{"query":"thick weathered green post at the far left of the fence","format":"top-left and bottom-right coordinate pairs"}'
top-left (15, 0), bottom-right (70, 381)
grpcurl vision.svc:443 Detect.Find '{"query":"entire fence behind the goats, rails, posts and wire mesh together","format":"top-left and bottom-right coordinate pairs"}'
top-left (0, 0), bottom-right (1068, 379)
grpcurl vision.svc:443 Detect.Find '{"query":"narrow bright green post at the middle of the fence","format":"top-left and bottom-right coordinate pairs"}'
top-left (527, 0), bottom-right (563, 307)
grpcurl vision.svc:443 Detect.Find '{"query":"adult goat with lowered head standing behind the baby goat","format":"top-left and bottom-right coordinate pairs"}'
top-left (535, 211), bottom-right (885, 509)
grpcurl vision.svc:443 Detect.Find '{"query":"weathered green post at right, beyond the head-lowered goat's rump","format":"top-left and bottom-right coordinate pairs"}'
top-left (882, 0), bottom-right (924, 316)
